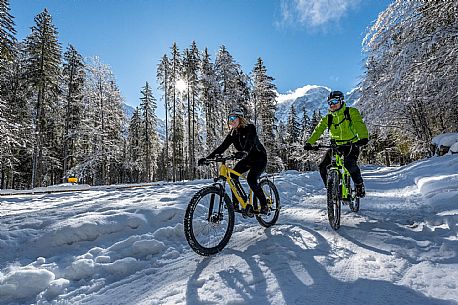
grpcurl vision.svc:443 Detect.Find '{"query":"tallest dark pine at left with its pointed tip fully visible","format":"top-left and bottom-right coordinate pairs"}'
top-left (25, 9), bottom-right (61, 187)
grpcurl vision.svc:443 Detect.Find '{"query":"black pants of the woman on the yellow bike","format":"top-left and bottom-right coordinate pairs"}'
top-left (231, 157), bottom-right (267, 207)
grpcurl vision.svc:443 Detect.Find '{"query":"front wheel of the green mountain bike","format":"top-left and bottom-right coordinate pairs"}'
top-left (327, 170), bottom-right (341, 230)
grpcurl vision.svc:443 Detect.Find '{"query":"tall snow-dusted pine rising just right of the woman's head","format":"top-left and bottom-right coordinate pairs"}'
top-left (251, 58), bottom-right (283, 171)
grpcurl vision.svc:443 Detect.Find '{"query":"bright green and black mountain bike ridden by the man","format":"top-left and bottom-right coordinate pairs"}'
top-left (313, 144), bottom-right (360, 230)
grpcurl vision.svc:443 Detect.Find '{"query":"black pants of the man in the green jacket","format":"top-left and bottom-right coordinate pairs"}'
top-left (318, 145), bottom-right (363, 186)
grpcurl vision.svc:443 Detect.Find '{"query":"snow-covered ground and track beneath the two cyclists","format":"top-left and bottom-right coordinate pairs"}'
top-left (0, 156), bottom-right (458, 305)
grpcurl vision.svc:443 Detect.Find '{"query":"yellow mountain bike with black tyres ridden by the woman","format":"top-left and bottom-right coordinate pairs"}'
top-left (184, 155), bottom-right (280, 256)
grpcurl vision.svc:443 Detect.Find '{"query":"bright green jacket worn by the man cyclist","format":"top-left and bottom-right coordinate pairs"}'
top-left (307, 103), bottom-right (369, 145)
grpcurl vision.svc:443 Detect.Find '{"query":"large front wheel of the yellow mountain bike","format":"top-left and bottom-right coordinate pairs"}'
top-left (184, 186), bottom-right (235, 256)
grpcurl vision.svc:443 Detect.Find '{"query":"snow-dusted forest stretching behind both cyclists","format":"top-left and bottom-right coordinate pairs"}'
top-left (0, 0), bottom-right (458, 189)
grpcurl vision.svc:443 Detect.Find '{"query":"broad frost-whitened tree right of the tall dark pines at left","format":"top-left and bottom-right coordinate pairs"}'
top-left (75, 57), bottom-right (126, 185)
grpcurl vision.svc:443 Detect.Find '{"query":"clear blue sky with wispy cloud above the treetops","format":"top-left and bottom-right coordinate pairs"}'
top-left (10, 0), bottom-right (391, 117)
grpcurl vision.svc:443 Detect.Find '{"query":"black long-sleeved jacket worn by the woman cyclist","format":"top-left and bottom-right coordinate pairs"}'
top-left (207, 124), bottom-right (267, 161)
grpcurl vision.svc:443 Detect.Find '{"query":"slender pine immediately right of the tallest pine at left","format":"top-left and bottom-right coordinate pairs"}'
top-left (62, 45), bottom-right (86, 177)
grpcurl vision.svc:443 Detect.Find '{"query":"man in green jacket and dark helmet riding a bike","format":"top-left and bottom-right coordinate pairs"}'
top-left (304, 91), bottom-right (369, 197)
